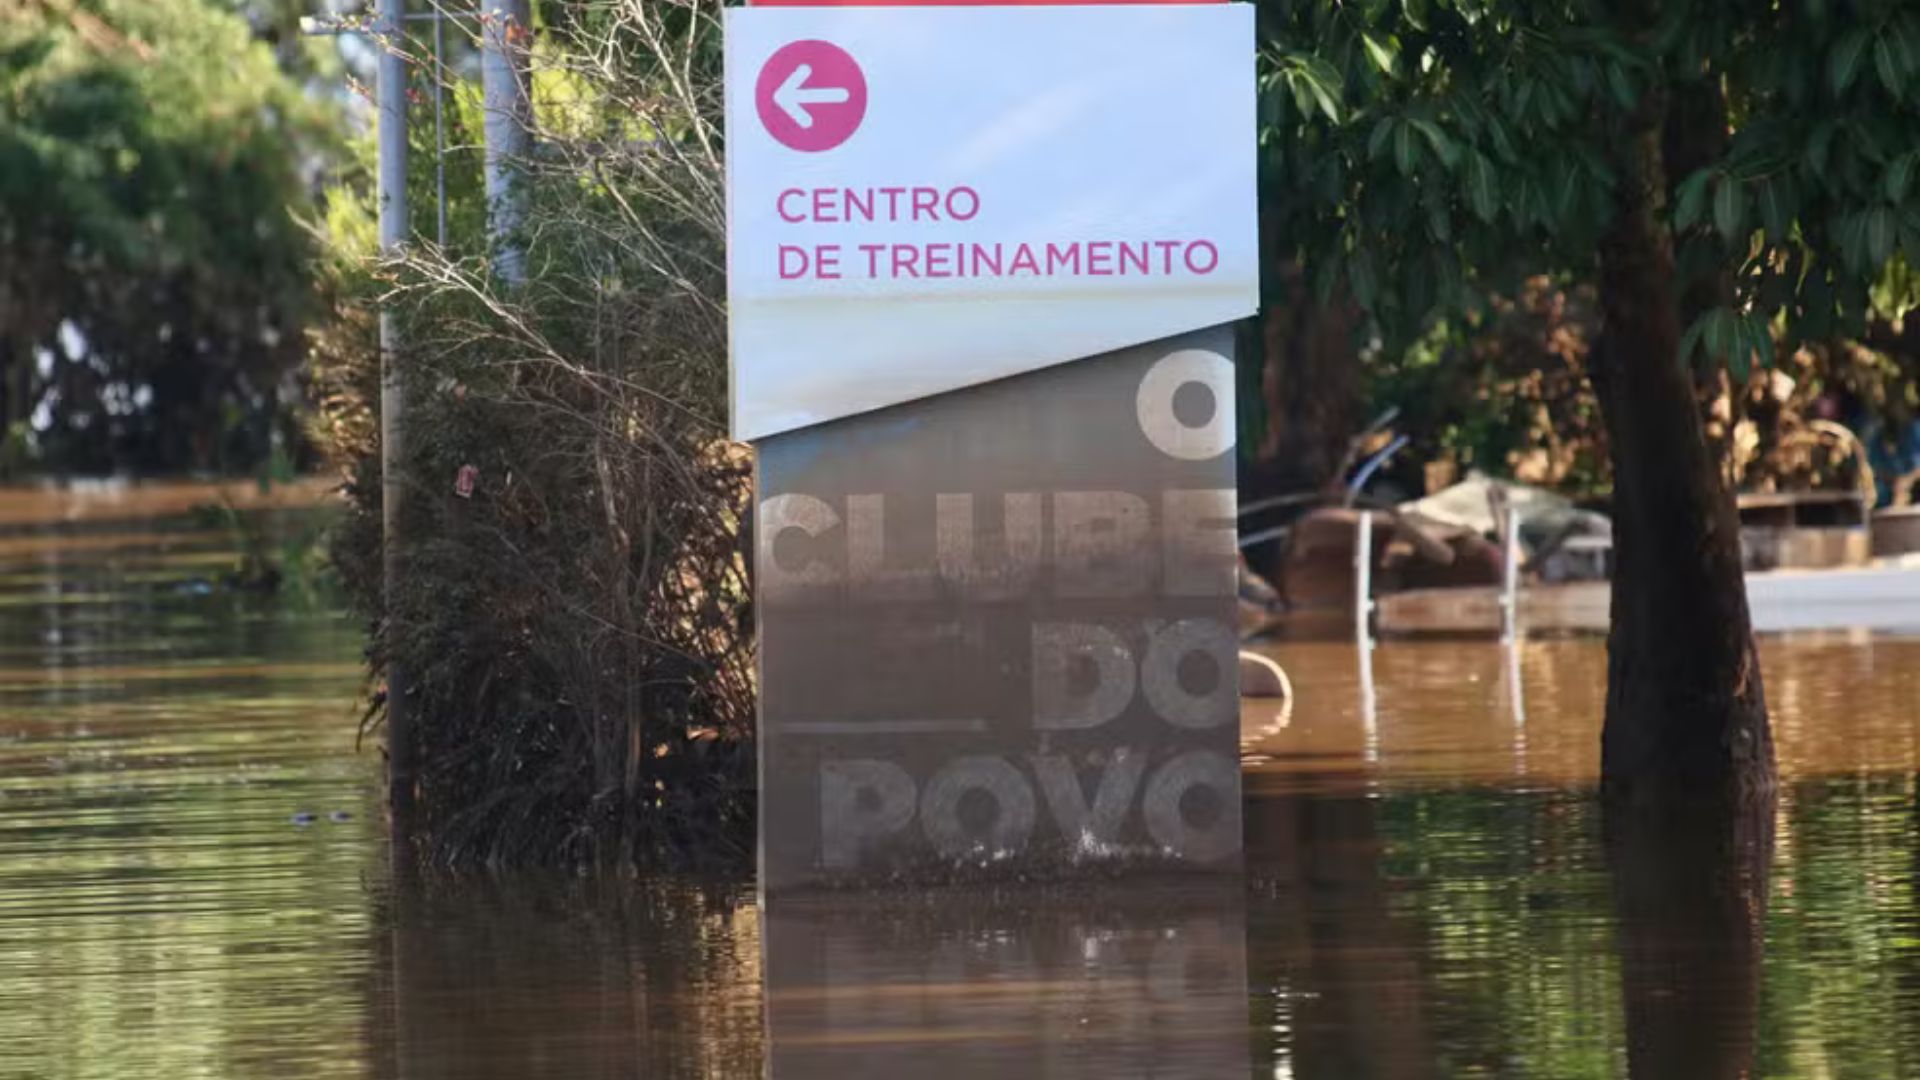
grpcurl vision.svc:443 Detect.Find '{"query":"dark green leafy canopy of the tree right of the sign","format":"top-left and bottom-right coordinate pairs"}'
top-left (1260, 0), bottom-right (1920, 377)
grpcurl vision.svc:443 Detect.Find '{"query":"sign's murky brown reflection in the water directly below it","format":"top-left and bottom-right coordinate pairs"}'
top-left (764, 878), bottom-right (1248, 1080)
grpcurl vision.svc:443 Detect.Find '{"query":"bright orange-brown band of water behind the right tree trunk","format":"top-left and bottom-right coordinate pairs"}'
top-left (1242, 632), bottom-right (1920, 794)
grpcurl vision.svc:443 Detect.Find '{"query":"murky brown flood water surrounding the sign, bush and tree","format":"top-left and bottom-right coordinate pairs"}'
top-left (0, 486), bottom-right (1920, 1080)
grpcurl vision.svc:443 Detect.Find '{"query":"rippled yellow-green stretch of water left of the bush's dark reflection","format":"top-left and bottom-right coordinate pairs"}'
top-left (0, 488), bottom-right (380, 1078)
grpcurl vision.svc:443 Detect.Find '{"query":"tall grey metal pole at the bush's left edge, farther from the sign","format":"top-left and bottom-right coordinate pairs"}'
top-left (376, 0), bottom-right (413, 821)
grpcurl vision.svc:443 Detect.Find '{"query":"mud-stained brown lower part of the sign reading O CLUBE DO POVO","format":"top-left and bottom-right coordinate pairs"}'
top-left (756, 327), bottom-right (1240, 890)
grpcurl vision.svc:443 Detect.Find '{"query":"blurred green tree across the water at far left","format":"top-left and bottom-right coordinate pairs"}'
top-left (0, 0), bottom-right (324, 471)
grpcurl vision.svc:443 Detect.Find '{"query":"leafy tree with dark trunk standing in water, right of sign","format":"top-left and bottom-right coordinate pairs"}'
top-left (1260, 0), bottom-right (1920, 794)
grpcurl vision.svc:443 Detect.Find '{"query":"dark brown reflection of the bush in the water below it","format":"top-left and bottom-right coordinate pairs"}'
top-left (367, 874), bottom-right (762, 1080)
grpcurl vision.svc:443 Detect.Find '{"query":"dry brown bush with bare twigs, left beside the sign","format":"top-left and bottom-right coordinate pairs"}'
top-left (313, 4), bottom-right (753, 863)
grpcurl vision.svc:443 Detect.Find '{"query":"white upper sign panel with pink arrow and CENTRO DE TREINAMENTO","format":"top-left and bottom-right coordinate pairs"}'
top-left (726, 4), bottom-right (1260, 438)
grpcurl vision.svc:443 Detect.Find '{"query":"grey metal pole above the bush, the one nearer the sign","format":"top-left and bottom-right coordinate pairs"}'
top-left (480, 0), bottom-right (534, 284)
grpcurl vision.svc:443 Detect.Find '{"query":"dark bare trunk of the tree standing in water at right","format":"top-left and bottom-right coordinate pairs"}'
top-left (1594, 90), bottom-right (1774, 799)
